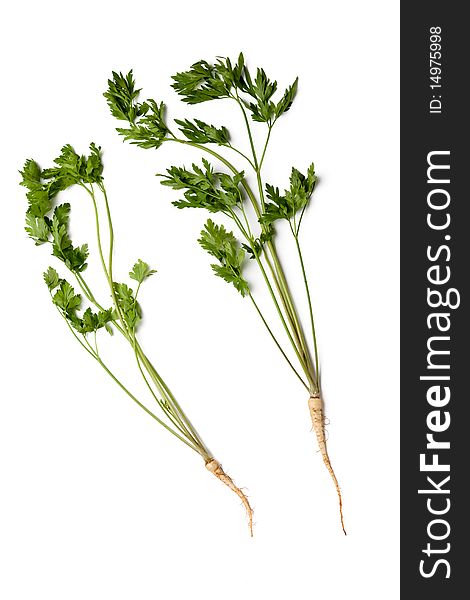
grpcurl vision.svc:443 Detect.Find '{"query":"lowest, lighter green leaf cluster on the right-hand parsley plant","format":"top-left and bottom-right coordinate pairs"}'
top-left (198, 219), bottom-right (250, 296)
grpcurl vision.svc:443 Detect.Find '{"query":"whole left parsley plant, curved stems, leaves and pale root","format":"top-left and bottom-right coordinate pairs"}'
top-left (21, 144), bottom-right (253, 535)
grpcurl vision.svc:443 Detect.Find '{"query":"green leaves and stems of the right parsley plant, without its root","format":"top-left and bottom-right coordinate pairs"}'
top-left (104, 54), bottom-right (320, 395)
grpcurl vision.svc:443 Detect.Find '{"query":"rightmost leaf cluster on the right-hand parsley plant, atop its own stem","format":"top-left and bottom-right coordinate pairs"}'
top-left (260, 163), bottom-right (317, 234)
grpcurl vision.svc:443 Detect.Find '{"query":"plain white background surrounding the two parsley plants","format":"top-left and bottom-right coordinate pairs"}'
top-left (0, 0), bottom-right (399, 600)
